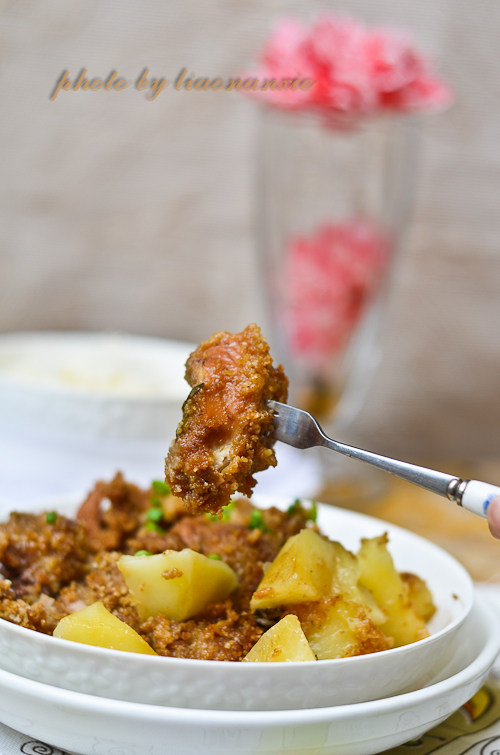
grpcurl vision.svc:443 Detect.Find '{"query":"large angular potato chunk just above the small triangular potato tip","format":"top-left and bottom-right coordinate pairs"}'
top-left (250, 529), bottom-right (336, 611)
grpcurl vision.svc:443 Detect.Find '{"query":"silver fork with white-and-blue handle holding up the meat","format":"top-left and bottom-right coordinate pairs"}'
top-left (267, 400), bottom-right (500, 518)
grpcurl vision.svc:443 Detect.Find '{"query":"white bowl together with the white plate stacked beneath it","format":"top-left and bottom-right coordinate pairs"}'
top-left (0, 500), bottom-right (500, 755)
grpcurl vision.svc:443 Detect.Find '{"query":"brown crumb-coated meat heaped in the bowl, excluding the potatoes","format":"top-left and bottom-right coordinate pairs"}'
top-left (0, 488), bottom-right (309, 661)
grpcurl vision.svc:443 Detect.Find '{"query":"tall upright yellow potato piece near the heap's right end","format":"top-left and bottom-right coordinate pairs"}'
top-left (358, 535), bottom-right (429, 647)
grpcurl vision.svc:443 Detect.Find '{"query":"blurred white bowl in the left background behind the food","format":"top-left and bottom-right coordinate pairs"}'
top-left (0, 332), bottom-right (193, 504)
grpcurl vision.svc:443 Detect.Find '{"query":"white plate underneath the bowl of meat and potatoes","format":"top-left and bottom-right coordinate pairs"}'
top-left (0, 598), bottom-right (500, 755)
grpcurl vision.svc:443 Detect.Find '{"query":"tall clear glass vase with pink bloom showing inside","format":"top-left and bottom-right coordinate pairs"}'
top-left (257, 109), bottom-right (418, 497)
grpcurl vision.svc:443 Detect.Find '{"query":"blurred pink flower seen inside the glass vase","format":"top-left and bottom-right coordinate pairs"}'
top-left (284, 219), bottom-right (391, 369)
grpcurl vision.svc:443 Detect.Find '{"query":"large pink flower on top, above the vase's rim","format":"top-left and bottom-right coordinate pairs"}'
top-left (248, 15), bottom-right (452, 120)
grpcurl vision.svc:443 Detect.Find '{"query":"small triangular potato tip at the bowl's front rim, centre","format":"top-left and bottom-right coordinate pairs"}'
top-left (243, 614), bottom-right (316, 663)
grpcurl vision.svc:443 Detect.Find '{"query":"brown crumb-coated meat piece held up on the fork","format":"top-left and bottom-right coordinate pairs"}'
top-left (165, 325), bottom-right (288, 513)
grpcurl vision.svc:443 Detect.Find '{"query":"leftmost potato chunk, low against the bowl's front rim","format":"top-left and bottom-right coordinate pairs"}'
top-left (54, 601), bottom-right (156, 655)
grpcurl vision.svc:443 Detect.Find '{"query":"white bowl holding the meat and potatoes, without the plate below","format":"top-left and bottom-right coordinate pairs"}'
top-left (0, 500), bottom-right (474, 710)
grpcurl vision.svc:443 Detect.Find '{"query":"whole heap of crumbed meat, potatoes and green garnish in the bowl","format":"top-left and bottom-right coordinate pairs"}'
top-left (0, 475), bottom-right (434, 662)
